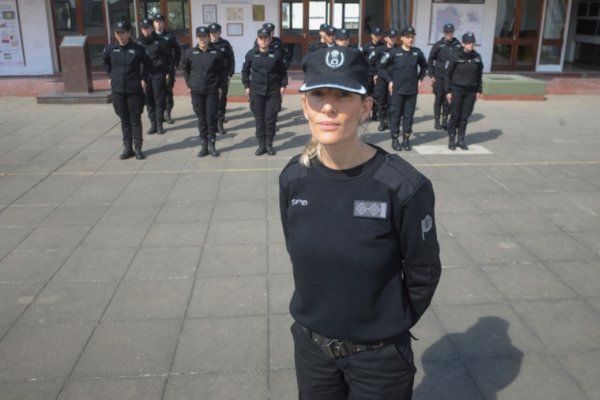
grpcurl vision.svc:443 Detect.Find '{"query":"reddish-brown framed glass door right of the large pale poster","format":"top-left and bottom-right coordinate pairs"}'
top-left (492, 0), bottom-right (543, 71)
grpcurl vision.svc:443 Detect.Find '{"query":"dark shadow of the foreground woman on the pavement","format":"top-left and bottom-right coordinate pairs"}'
top-left (413, 317), bottom-right (523, 400)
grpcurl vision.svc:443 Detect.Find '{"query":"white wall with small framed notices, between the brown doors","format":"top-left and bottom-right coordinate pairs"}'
top-left (191, 0), bottom-right (280, 73)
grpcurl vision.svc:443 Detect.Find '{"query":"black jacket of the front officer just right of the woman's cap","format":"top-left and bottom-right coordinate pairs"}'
top-left (379, 46), bottom-right (427, 95)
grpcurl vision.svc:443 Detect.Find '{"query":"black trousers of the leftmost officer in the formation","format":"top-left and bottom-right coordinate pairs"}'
top-left (112, 92), bottom-right (144, 143)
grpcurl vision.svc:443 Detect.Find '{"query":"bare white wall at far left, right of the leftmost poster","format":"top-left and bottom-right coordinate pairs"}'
top-left (0, 0), bottom-right (58, 76)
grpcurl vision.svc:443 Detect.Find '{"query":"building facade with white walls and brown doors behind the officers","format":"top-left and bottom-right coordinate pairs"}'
top-left (0, 0), bottom-right (600, 76)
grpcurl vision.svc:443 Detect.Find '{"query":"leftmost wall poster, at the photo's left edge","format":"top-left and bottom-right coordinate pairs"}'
top-left (0, 0), bottom-right (25, 67)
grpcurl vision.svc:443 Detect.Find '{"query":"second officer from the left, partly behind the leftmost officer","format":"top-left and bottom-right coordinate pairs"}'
top-left (137, 18), bottom-right (172, 135)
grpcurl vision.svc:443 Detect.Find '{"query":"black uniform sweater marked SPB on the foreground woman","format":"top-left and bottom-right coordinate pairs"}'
top-left (279, 147), bottom-right (441, 342)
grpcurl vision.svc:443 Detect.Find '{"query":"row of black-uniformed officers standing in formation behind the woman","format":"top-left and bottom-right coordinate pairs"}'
top-left (103, 15), bottom-right (483, 159)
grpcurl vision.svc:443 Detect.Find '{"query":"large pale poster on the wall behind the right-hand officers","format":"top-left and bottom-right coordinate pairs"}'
top-left (429, 0), bottom-right (484, 44)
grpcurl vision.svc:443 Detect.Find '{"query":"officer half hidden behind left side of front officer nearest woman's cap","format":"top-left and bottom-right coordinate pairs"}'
top-left (373, 29), bottom-right (398, 132)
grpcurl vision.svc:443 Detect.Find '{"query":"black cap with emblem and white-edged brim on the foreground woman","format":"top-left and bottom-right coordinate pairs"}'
top-left (300, 47), bottom-right (369, 94)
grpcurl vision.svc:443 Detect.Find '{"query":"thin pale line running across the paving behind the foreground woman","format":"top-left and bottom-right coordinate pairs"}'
top-left (0, 160), bottom-right (600, 177)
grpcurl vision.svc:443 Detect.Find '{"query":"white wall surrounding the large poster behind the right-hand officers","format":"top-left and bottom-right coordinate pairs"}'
top-left (413, 0), bottom-right (496, 72)
